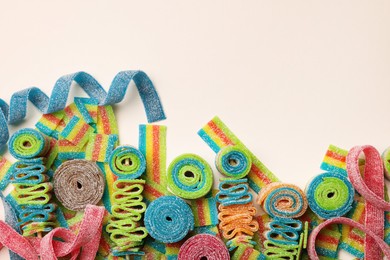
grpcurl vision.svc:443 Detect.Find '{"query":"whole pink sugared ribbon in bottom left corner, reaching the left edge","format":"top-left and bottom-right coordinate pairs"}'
top-left (0, 205), bottom-right (105, 260)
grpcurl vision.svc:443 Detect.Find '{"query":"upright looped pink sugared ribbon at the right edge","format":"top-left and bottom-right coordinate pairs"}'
top-left (347, 145), bottom-right (390, 259)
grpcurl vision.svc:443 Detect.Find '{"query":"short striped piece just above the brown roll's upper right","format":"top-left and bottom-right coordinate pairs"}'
top-left (85, 134), bottom-right (118, 162)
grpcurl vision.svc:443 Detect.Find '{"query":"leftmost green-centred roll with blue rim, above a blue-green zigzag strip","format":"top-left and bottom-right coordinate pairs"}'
top-left (8, 128), bottom-right (50, 159)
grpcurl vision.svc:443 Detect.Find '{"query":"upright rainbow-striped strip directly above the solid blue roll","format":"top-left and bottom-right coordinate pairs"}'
top-left (139, 125), bottom-right (167, 203)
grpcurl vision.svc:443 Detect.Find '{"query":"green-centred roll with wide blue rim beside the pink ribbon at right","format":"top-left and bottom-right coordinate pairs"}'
top-left (306, 172), bottom-right (355, 219)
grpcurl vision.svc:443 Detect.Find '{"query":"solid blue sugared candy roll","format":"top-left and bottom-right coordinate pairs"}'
top-left (144, 196), bottom-right (194, 243)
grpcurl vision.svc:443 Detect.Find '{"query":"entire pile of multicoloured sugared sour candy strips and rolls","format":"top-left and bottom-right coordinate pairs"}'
top-left (0, 71), bottom-right (390, 260)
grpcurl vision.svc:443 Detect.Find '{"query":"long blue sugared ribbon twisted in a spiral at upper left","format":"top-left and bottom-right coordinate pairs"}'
top-left (0, 71), bottom-right (165, 149)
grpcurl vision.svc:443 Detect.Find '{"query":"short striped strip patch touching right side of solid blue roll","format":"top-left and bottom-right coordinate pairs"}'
top-left (190, 197), bottom-right (218, 227)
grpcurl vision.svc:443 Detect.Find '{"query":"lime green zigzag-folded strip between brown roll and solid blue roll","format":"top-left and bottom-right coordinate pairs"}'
top-left (106, 180), bottom-right (148, 256)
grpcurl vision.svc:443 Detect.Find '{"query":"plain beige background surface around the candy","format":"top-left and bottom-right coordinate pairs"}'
top-left (0, 0), bottom-right (390, 259)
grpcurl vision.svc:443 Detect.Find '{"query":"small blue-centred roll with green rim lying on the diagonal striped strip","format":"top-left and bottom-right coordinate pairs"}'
top-left (215, 145), bottom-right (252, 179)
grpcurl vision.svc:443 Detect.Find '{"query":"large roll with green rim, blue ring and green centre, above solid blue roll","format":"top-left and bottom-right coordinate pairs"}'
top-left (167, 154), bottom-right (213, 199)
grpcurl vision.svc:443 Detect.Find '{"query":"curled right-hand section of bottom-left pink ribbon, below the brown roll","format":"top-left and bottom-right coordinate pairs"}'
top-left (40, 205), bottom-right (105, 260)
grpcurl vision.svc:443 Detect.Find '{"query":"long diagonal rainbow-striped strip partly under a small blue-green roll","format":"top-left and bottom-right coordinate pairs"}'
top-left (198, 117), bottom-right (279, 193)
